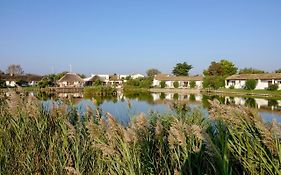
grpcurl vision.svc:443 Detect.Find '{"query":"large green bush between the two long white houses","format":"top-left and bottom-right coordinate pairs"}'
top-left (203, 76), bottom-right (225, 89)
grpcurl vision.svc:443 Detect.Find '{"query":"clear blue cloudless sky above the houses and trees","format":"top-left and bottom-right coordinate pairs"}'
top-left (0, 0), bottom-right (281, 74)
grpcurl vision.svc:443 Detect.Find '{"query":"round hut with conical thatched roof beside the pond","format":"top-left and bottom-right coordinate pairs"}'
top-left (58, 73), bottom-right (84, 87)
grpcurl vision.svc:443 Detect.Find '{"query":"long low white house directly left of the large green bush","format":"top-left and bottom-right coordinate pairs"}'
top-left (152, 74), bottom-right (203, 89)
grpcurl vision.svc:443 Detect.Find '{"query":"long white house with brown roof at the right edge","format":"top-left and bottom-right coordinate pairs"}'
top-left (225, 73), bottom-right (281, 89)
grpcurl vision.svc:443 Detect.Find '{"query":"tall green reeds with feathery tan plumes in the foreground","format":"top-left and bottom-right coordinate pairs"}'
top-left (0, 93), bottom-right (281, 175)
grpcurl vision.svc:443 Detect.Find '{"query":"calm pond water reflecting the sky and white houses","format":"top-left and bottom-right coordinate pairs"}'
top-left (33, 90), bottom-right (281, 124)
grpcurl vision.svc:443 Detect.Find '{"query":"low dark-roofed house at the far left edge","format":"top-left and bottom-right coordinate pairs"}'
top-left (0, 74), bottom-right (42, 87)
